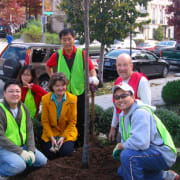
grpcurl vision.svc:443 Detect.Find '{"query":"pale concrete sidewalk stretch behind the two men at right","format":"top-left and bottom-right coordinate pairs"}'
top-left (95, 76), bottom-right (180, 109)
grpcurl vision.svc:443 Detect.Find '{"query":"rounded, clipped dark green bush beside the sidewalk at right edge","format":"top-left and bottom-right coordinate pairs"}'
top-left (162, 80), bottom-right (180, 104)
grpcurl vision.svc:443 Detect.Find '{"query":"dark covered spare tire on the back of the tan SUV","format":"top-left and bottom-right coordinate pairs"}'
top-left (3, 59), bottom-right (21, 79)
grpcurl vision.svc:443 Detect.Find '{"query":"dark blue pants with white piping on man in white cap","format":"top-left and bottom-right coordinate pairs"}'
top-left (118, 148), bottom-right (168, 180)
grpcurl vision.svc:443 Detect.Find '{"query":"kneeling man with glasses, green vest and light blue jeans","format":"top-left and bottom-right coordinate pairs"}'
top-left (0, 81), bottom-right (47, 179)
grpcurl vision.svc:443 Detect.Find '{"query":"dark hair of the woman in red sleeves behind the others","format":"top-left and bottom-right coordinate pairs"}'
top-left (17, 65), bottom-right (37, 85)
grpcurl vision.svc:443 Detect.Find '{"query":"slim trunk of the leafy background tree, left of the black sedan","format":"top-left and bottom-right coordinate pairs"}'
top-left (98, 43), bottom-right (104, 87)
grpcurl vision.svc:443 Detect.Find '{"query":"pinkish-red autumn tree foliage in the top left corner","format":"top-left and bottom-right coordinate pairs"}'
top-left (0, 0), bottom-right (25, 24)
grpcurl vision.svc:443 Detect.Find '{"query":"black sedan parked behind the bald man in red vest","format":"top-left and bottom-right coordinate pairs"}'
top-left (104, 49), bottom-right (169, 77)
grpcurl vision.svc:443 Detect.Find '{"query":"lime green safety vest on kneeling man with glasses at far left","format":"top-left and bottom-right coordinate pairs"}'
top-left (0, 103), bottom-right (27, 146)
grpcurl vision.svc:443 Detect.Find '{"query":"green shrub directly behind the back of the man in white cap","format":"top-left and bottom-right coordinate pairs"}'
top-left (155, 108), bottom-right (180, 147)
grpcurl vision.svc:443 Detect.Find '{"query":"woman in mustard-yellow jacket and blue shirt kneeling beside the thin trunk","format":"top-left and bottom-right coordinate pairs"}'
top-left (41, 73), bottom-right (78, 159)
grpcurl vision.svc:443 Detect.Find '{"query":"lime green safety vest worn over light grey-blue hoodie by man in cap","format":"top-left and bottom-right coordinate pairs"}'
top-left (121, 106), bottom-right (177, 154)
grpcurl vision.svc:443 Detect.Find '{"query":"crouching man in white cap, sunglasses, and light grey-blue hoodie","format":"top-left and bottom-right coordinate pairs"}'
top-left (112, 83), bottom-right (179, 180)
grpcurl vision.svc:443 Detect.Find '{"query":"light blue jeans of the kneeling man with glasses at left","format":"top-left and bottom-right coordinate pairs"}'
top-left (0, 146), bottom-right (47, 177)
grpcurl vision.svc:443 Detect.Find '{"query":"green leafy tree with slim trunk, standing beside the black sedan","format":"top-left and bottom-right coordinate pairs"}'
top-left (59, 0), bottom-right (149, 84)
